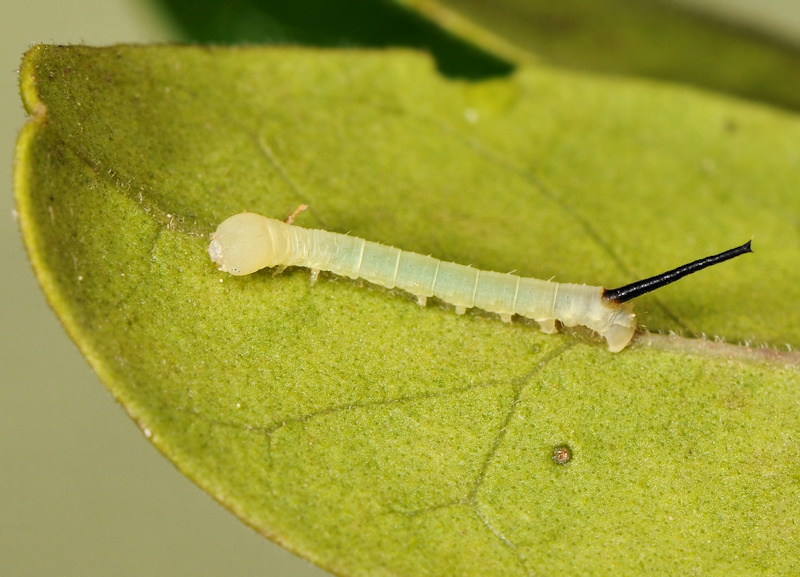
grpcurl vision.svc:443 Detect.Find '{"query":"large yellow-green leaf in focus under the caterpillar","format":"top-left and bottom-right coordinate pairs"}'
top-left (15, 46), bottom-right (800, 575)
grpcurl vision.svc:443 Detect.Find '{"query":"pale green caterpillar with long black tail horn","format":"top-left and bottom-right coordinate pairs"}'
top-left (208, 212), bottom-right (752, 352)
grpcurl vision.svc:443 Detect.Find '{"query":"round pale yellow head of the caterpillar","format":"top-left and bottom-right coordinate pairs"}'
top-left (208, 212), bottom-right (285, 275)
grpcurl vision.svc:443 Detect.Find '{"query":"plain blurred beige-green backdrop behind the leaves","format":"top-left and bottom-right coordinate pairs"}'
top-left (0, 0), bottom-right (800, 577)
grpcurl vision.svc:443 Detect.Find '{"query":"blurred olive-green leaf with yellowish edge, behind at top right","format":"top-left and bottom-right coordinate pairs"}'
top-left (400, 0), bottom-right (800, 110)
